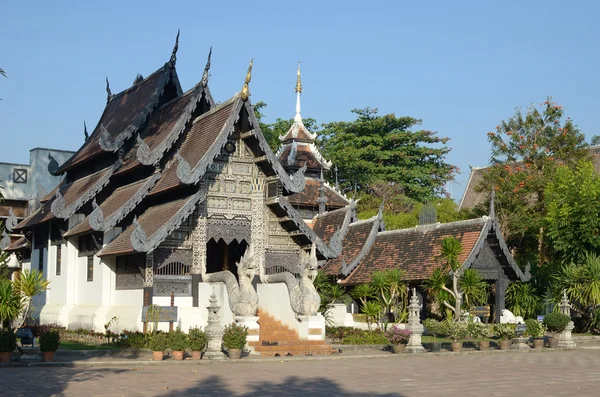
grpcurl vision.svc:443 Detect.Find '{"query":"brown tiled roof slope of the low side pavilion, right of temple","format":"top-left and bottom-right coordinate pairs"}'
top-left (343, 218), bottom-right (486, 284)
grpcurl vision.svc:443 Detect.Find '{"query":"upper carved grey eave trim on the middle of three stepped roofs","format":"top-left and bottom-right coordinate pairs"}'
top-left (136, 84), bottom-right (212, 165)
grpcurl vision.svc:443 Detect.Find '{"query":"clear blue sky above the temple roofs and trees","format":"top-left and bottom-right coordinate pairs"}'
top-left (0, 0), bottom-right (600, 199)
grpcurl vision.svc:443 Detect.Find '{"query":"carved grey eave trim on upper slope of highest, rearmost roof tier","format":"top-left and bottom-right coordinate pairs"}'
top-left (98, 63), bottom-right (172, 152)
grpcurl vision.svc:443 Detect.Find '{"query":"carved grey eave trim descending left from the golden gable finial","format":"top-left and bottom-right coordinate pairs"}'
top-left (175, 96), bottom-right (243, 185)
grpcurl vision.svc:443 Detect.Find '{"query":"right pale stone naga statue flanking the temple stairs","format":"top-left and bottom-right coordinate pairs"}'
top-left (260, 244), bottom-right (321, 317)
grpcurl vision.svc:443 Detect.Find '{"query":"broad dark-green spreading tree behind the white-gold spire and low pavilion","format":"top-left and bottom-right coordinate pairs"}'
top-left (319, 108), bottom-right (456, 201)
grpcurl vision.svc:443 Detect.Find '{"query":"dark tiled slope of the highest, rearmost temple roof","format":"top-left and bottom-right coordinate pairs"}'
top-left (58, 65), bottom-right (171, 172)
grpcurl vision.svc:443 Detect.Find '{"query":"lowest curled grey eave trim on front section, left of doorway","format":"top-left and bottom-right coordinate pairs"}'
top-left (129, 189), bottom-right (207, 252)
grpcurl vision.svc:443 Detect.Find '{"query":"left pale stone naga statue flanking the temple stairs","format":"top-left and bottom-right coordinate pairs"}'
top-left (202, 245), bottom-right (258, 317)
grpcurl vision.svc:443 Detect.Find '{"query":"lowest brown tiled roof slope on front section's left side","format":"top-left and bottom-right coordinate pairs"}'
top-left (98, 197), bottom-right (190, 256)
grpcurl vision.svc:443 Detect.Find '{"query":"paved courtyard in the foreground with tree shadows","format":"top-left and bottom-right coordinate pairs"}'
top-left (0, 350), bottom-right (600, 397)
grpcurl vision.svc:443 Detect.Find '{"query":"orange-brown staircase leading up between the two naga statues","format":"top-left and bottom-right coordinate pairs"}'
top-left (249, 310), bottom-right (334, 357)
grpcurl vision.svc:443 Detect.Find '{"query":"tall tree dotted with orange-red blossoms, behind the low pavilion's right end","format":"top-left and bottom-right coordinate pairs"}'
top-left (478, 98), bottom-right (588, 263)
